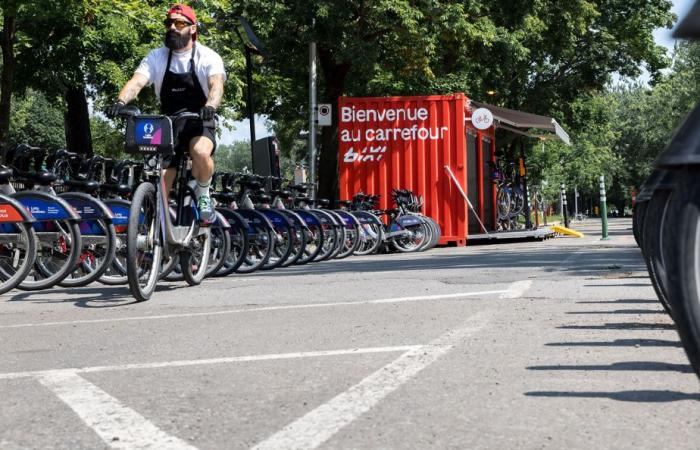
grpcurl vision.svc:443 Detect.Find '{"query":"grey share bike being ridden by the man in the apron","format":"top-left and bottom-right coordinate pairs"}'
top-left (120, 106), bottom-right (211, 301)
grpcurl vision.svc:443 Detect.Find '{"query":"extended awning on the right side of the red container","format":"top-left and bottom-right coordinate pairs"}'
top-left (471, 100), bottom-right (571, 145)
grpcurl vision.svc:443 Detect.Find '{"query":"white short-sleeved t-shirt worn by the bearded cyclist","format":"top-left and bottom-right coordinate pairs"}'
top-left (136, 44), bottom-right (226, 100)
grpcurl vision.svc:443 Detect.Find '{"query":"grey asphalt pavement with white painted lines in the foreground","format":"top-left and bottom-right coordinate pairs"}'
top-left (0, 219), bottom-right (700, 450)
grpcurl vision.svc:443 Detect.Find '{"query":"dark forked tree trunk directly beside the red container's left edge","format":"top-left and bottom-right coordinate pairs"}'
top-left (318, 48), bottom-right (351, 201)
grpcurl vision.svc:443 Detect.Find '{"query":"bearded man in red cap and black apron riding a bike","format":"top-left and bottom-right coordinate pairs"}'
top-left (107, 4), bottom-right (226, 222)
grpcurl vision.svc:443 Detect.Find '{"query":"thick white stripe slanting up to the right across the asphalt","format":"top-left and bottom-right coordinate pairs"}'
top-left (253, 313), bottom-right (487, 450)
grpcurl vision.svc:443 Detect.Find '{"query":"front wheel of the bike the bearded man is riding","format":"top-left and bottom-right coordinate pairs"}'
top-left (126, 183), bottom-right (163, 302)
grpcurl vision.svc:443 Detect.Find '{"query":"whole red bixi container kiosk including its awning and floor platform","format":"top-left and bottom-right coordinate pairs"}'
top-left (338, 93), bottom-right (570, 246)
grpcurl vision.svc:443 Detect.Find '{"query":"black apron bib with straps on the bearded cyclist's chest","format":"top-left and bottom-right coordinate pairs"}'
top-left (160, 46), bottom-right (207, 116)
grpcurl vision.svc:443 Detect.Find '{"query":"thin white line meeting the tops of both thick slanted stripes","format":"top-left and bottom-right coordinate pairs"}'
top-left (0, 345), bottom-right (420, 380)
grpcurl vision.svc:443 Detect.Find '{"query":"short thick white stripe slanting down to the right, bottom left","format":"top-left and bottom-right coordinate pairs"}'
top-left (39, 370), bottom-right (196, 449)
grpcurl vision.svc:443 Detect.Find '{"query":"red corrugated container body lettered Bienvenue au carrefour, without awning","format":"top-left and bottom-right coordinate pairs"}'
top-left (338, 94), bottom-right (494, 245)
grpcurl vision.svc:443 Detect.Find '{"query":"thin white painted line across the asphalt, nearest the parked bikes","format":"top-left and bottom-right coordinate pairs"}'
top-left (0, 289), bottom-right (509, 330)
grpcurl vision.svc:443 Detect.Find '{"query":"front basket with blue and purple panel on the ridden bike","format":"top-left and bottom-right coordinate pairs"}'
top-left (125, 116), bottom-right (174, 155)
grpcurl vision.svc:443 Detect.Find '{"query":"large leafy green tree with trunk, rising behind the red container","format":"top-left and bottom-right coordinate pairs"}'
top-left (227, 0), bottom-right (674, 197)
